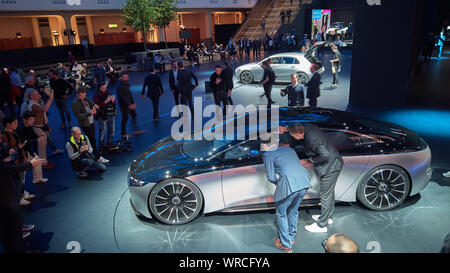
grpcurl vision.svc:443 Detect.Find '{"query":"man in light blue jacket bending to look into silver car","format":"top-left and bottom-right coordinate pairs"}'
top-left (261, 135), bottom-right (311, 253)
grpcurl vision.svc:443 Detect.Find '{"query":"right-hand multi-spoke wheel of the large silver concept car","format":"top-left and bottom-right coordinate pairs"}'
top-left (357, 165), bottom-right (411, 211)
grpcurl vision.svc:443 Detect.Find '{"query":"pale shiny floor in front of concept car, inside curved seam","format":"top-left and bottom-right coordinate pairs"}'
top-left (114, 173), bottom-right (450, 253)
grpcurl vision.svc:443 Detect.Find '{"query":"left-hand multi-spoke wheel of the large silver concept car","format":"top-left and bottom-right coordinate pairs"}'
top-left (148, 178), bottom-right (203, 225)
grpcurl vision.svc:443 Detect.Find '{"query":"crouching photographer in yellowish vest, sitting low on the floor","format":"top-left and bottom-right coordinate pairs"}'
top-left (66, 127), bottom-right (106, 177)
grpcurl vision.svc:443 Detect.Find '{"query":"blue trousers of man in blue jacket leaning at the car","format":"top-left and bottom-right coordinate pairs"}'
top-left (276, 189), bottom-right (308, 248)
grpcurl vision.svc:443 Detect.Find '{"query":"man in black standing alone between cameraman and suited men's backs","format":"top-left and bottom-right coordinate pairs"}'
top-left (117, 72), bottom-right (144, 138)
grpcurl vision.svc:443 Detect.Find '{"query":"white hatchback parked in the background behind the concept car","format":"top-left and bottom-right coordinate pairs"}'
top-left (235, 52), bottom-right (325, 84)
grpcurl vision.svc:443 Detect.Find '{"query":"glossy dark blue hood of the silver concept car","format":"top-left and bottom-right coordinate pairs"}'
top-left (130, 137), bottom-right (221, 183)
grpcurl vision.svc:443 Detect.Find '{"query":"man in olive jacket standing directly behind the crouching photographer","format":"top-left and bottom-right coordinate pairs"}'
top-left (71, 86), bottom-right (109, 163)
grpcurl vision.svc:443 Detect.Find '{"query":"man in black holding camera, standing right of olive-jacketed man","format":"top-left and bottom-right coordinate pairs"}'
top-left (93, 82), bottom-right (117, 149)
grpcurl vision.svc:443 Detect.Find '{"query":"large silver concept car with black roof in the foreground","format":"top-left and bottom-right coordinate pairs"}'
top-left (128, 108), bottom-right (431, 225)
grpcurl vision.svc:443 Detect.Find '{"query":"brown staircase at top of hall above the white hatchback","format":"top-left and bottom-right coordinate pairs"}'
top-left (235, 0), bottom-right (301, 41)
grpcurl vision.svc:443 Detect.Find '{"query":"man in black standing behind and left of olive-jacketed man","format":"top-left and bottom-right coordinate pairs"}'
top-left (49, 70), bottom-right (73, 129)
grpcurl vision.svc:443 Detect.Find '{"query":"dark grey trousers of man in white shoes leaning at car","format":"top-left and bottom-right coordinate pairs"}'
top-left (317, 159), bottom-right (342, 227)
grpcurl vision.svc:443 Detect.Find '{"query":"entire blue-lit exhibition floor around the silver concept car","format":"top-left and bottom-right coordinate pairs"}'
top-left (13, 51), bottom-right (450, 253)
